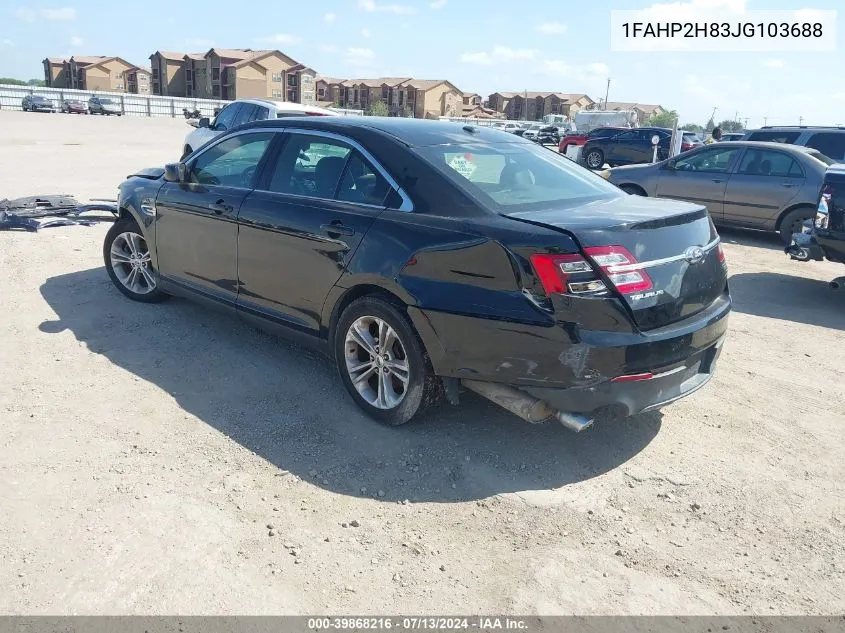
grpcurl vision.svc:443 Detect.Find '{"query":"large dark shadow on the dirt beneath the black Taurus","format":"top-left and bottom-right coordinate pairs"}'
top-left (39, 268), bottom-right (662, 502)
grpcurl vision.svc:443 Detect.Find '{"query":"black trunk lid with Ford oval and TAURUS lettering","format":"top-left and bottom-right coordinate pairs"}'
top-left (504, 196), bottom-right (727, 330)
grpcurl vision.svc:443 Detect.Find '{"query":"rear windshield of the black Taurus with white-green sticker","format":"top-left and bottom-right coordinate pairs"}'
top-left (416, 143), bottom-right (620, 210)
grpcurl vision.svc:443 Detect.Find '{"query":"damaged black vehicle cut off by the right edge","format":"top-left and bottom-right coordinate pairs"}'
top-left (786, 165), bottom-right (845, 290)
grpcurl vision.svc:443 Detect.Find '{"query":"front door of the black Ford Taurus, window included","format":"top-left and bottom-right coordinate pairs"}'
top-left (156, 132), bottom-right (273, 304)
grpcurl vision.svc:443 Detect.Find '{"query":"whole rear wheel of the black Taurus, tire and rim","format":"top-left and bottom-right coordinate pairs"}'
top-left (333, 296), bottom-right (439, 426)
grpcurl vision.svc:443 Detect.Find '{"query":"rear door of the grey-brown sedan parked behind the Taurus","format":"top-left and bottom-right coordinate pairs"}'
top-left (724, 148), bottom-right (806, 229)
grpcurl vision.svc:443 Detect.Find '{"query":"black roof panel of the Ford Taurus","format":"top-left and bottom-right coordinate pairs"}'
top-left (238, 116), bottom-right (532, 147)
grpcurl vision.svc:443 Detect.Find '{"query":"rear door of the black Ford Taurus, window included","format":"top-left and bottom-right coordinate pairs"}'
top-left (238, 131), bottom-right (392, 333)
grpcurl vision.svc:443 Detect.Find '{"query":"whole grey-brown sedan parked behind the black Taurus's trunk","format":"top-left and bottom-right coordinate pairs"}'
top-left (605, 141), bottom-right (832, 244)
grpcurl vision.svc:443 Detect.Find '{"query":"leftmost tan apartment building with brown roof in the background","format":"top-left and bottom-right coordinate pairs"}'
top-left (43, 55), bottom-right (149, 94)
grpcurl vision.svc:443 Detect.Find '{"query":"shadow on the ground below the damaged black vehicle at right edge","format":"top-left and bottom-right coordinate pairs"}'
top-left (730, 270), bottom-right (845, 330)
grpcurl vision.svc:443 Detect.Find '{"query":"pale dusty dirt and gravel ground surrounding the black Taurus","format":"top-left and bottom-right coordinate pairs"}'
top-left (0, 112), bottom-right (845, 614)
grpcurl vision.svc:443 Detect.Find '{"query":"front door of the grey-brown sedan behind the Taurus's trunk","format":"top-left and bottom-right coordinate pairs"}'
top-left (657, 147), bottom-right (741, 222)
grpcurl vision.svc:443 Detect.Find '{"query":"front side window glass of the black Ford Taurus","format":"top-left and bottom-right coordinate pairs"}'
top-left (190, 132), bottom-right (273, 188)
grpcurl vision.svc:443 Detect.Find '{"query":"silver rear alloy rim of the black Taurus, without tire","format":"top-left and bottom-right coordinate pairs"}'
top-left (344, 316), bottom-right (410, 409)
